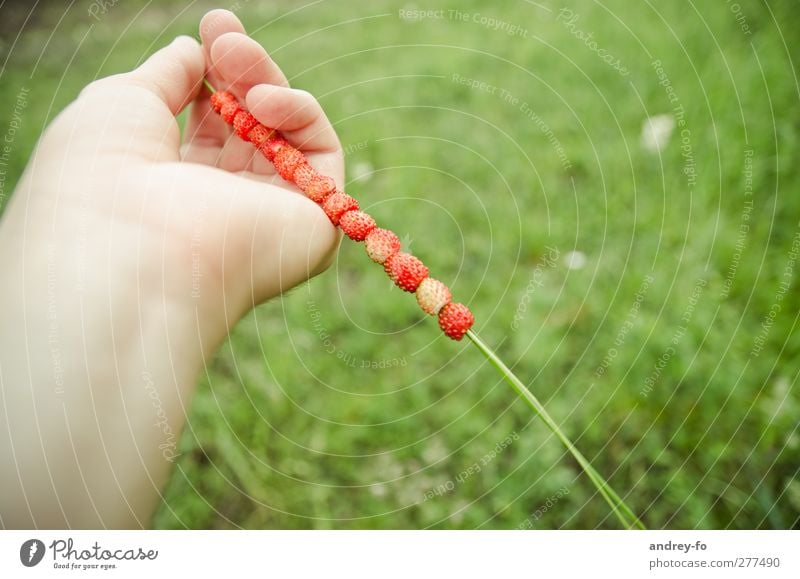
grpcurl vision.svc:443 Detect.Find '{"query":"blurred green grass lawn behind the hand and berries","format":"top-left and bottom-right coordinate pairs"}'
top-left (0, 0), bottom-right (800, 528)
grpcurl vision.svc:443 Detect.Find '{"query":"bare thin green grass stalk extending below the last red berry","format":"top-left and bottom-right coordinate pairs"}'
top-left (467, 330), bottom-right (645, 529)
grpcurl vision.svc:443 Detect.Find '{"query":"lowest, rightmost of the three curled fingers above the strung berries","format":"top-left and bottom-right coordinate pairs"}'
top-left (247, 84), bottom-right (341, 153)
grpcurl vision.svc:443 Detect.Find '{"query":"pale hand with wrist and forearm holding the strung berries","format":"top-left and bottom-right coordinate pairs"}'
top-left (0, 10), bottom-right (344, 528)
